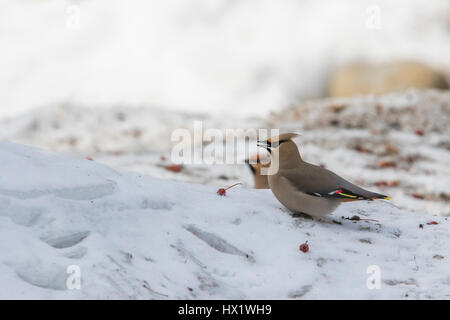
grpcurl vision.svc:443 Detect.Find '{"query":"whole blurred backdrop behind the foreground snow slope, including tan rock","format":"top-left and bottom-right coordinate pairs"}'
top-left (0, 0), bottom-right (450, 215)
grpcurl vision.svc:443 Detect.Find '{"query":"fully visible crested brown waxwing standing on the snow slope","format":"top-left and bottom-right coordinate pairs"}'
top-left (258, 133), bottom-right (390, 218)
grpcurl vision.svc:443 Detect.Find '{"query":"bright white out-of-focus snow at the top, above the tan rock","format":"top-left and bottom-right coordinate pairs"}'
top-left (0, 0), bottom-right (450, 116)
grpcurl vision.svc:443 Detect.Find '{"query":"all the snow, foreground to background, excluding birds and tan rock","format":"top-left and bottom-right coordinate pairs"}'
top-left (0, 0), bottom-right (450, 299)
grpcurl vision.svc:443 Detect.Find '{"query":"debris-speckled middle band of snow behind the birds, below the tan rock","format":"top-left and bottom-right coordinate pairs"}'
top-left (0, 90), bottom-right (450, 216)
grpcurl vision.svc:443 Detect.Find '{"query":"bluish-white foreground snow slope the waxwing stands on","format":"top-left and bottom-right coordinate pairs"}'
top-left (0, 143), bottom-right (450, 299)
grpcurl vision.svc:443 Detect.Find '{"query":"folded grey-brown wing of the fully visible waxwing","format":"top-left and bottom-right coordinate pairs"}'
top-left (283, 163), bottom-right (389, 201)
